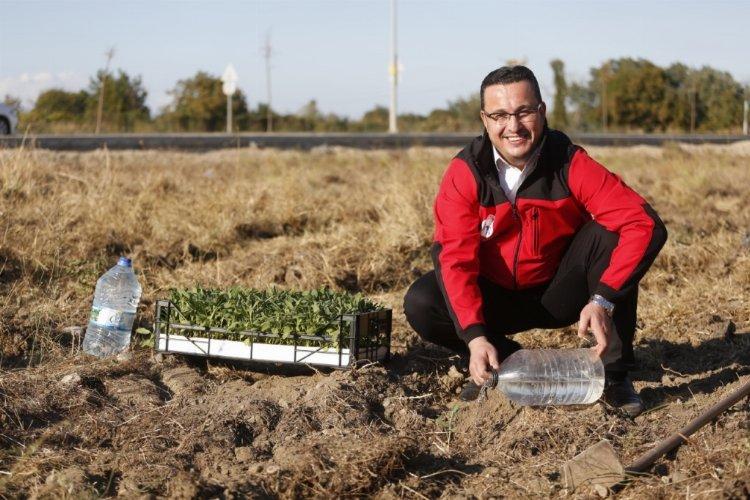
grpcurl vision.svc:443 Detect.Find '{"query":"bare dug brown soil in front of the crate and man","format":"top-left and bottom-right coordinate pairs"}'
top-left (0, 333), bottom-right (750, 498)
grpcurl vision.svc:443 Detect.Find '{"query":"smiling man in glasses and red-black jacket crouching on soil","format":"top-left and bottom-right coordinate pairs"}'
top-left (404, 66), bottom-right (667, 416)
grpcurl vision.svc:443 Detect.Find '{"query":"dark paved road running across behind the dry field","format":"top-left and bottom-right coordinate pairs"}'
top-left (0, 133), bottom-right (750, 151)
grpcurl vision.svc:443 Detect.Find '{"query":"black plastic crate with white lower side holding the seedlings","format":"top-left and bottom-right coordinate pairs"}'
top-left (154, 300), bottom-right (392, 368)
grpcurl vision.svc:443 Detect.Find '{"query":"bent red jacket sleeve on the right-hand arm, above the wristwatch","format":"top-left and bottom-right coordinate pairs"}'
top-left (568, 149), bottom-right (667, 303)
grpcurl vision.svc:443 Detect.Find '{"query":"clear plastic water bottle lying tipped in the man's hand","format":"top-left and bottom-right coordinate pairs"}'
top-left (486, 349), bottom-right (604, 406)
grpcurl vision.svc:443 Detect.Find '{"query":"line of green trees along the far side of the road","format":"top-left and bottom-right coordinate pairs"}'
top-left (5, 58), bottom-right (750, 133)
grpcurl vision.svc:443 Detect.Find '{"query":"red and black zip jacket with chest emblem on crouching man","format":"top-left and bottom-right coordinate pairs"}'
top-left (432, 129), bottom-right (666, 342)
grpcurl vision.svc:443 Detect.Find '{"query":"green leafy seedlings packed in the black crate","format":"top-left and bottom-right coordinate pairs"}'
top-left (170, 287), bottom-right (382, 347)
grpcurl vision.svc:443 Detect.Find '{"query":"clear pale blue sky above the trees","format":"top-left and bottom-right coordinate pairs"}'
top-left (0, 0), bottom-right (750, 117)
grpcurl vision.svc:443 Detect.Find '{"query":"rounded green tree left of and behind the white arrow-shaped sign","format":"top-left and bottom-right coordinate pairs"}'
top-left (162, 71), bottom-right (249, 132)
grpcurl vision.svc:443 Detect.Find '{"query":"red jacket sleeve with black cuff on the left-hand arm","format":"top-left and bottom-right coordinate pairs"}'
top-left (432, 158), bottom-right (486, 343)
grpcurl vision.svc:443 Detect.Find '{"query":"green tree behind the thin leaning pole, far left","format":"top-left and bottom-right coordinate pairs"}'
top-left (86, 70), bottom-right (151, 132)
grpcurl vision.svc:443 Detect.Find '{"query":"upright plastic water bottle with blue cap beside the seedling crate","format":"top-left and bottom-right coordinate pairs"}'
top-left (83, 257), bottom-right (141, 357)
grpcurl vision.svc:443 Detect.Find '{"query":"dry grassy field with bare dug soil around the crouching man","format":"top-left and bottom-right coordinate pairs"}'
top-left (0, 143), bottom-right (750, 498)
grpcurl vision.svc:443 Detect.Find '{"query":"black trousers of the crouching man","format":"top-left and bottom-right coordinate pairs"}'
top-left (404, 221), bottom-right (638, 374)
